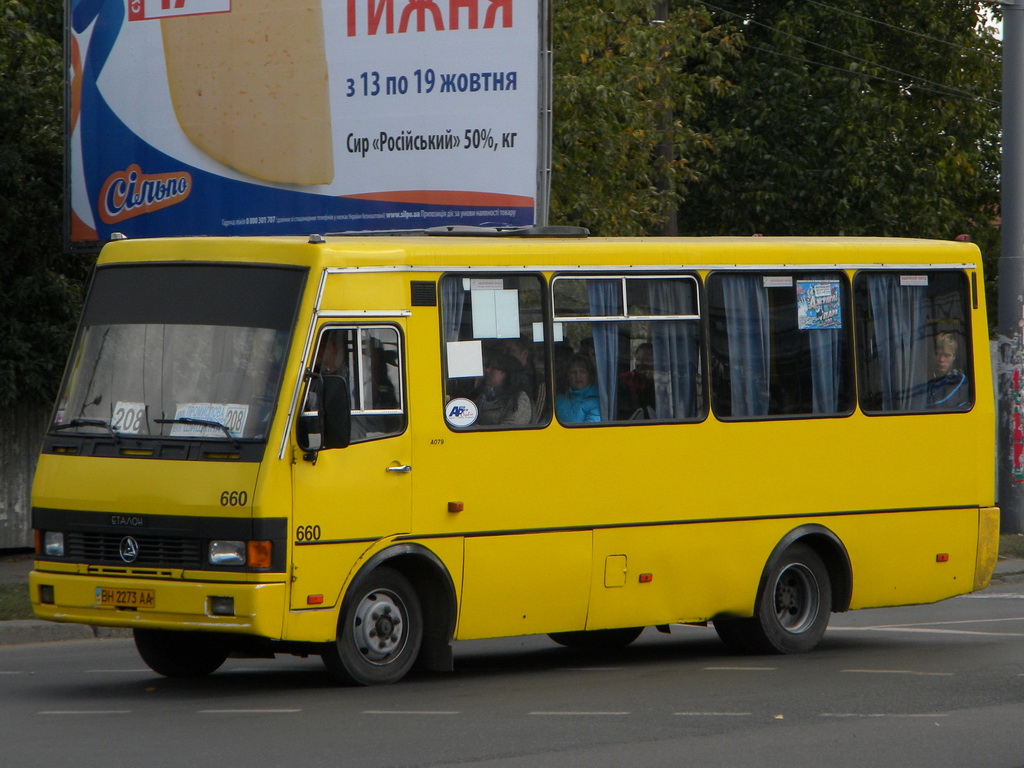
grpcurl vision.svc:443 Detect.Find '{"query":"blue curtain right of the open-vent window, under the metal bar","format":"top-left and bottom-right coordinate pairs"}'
top-left (647, 280), bottom-right (700, 421)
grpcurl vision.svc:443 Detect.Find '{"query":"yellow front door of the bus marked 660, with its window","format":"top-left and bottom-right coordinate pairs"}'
top-left (290, 321), bottom-right (413, 609)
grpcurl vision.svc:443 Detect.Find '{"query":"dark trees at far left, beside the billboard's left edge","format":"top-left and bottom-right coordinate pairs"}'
top-left (0, 0), bottom-right (91, 406)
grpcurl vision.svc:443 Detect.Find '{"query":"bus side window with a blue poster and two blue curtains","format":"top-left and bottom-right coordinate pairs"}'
top-left (708, 272), bottom-right (853, 419)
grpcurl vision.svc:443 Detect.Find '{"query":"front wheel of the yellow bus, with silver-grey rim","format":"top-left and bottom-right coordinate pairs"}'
top-left (322, 567), bottom-right (423, 685)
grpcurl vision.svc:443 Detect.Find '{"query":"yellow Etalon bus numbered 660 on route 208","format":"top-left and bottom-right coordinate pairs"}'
top-left (31, 227), bottom-right (998, 684)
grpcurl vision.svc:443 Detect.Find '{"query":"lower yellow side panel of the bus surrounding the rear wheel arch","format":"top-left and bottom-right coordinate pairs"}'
top-left (587, 509), bottom-right (978, 630)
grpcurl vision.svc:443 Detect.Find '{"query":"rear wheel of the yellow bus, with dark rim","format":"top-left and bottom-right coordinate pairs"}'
top-left (715, 544), bottom-right (831, 653)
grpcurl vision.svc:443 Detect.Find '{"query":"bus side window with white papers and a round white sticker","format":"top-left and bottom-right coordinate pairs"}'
top-left (441, 274), bottom-right (551, 430)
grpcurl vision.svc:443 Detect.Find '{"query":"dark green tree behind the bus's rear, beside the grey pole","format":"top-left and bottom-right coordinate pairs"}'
top-left (680, 0), bottom-right (1001, 308)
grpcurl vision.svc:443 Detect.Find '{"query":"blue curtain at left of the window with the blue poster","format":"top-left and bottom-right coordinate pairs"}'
top-left (721, 274), bottom-right (771, 418)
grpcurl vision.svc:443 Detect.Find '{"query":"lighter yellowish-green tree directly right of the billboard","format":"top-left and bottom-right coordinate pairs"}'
top-left (551, 0), bottom-right (736, 234)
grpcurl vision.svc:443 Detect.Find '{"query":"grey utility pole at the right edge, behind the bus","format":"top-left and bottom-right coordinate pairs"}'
top-left (996, 0), bottom-right (1024, 534)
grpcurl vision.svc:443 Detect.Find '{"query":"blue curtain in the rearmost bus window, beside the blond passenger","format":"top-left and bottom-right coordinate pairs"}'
top-left (867, 274), bottom-right (931, 411)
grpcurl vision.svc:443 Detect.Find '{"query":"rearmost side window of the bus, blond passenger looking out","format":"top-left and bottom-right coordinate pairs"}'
top-left (854, 271), bottom-right (974, 414)
